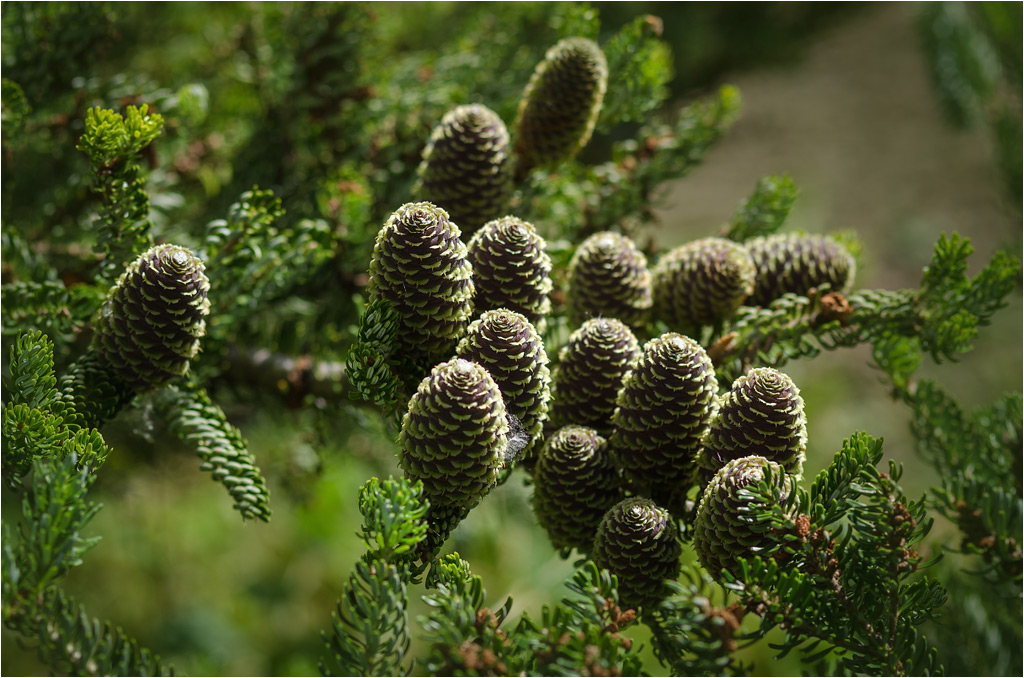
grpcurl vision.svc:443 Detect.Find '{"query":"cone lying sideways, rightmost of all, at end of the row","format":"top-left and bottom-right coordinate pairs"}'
top-left (746, 234), bottom-right (856, 306)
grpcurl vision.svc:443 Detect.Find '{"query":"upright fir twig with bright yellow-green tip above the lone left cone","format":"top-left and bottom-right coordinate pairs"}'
top-left (76, 104), bottom-right (164, 285)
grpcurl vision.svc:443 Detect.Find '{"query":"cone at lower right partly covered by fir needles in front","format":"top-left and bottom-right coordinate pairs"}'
top-left (693, 456), bottom-right (793, 579)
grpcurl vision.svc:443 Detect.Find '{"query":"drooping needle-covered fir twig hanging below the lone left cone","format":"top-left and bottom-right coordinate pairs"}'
top-left (158, 386), bottom-right (270, 522)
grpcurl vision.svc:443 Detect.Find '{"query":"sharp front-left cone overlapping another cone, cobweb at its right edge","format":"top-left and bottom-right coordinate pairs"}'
top-left (398, 358), bottom-right (509, 507)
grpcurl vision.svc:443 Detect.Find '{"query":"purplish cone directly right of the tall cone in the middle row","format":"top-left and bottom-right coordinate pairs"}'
top-left (467, 216), bottom-right (552, 334)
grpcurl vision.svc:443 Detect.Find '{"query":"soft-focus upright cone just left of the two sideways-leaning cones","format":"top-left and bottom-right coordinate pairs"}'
top-left (566, 231), bottom-right (652, 329)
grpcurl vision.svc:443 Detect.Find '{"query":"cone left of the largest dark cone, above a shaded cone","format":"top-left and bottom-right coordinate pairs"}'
top-left (549, 317), bottom-right (640, 435)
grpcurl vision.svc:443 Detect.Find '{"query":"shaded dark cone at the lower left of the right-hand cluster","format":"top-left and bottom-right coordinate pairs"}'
top-left (534, 426), bottom-right (623, 553)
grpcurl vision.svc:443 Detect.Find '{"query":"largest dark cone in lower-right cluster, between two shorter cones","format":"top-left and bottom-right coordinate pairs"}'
top-left (611, 332), bottom-right (718, 493)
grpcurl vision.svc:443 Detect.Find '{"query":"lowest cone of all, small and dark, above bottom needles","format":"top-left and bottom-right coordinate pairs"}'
top-left (592, 497), bottom-right (682, 608)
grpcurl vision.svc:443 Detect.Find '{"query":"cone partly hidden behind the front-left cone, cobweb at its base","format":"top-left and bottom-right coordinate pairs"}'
top-left (456, 308), bottom-right (551, 458)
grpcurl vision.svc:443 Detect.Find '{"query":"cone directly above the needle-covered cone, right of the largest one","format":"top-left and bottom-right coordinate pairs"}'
top-left (697, 368), bottom-right (807, 482)
